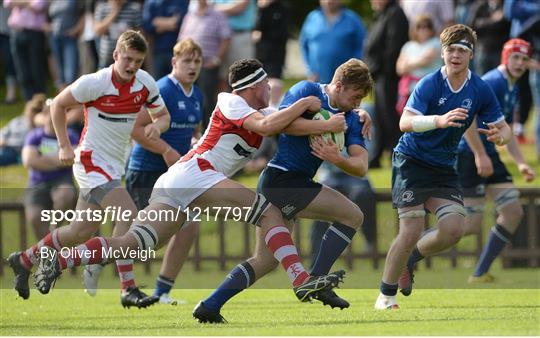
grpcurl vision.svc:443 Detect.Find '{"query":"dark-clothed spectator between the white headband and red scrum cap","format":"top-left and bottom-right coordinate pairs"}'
top-left (465, 0), bottom-right (510, 76)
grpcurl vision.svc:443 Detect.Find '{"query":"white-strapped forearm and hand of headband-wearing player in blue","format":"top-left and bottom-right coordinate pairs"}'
top-left (399, 108), bottom-right (467, 133)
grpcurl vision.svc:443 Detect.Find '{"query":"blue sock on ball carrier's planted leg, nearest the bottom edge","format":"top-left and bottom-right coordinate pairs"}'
top-left (203, 262), bottom-right (255, 312)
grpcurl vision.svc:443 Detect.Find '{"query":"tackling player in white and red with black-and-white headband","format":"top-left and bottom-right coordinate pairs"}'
top-left (35, 59), bottom-right (344, 316)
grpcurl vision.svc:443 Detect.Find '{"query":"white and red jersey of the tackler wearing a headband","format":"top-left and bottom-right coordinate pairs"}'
top-left (180, 93), bottom-right (271, 177)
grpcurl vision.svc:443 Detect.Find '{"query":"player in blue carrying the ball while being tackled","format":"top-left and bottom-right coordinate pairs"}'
top-left (193, 59), bottom-right (373, 322)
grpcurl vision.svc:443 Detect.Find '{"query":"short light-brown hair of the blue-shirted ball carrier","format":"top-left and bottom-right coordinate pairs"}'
top-left (332, 58), bottom-right (373, 95)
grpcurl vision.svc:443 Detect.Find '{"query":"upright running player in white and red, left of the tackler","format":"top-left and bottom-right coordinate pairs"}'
top-left (8, 30), bottom-right (170, 308)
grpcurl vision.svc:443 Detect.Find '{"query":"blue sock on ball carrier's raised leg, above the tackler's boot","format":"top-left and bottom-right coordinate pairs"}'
top-left (311, 222), bottom-right (356, 276)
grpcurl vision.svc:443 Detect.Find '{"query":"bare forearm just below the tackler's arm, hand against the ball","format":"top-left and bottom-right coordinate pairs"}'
top-left (282, 113), bottom-right (346, 136)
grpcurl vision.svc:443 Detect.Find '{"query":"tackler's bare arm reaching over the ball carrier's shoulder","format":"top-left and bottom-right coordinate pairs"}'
top-left (242, 96), bottom-right (321, 136)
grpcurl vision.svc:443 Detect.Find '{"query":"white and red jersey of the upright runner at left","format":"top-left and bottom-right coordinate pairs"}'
top-left (71, 66), bottom-right (163, 174)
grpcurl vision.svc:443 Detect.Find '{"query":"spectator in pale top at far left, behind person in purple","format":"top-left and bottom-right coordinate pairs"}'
top-left (0, 94), bottom-right (43, 166)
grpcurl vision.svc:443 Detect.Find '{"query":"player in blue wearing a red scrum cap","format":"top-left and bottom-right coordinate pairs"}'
top-left (456, 39), bottom-right (536, 283)
